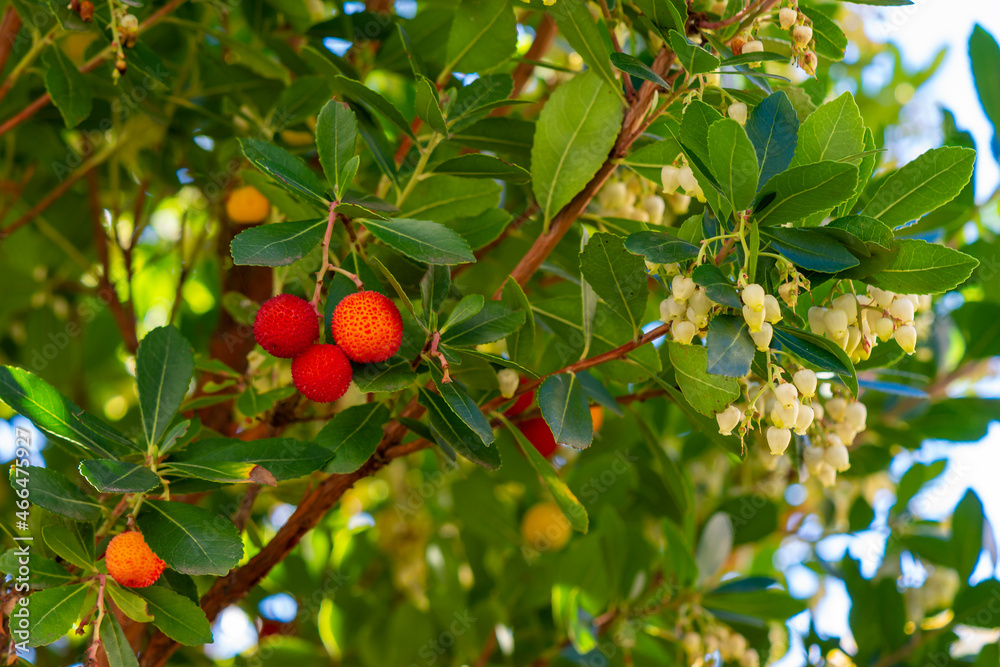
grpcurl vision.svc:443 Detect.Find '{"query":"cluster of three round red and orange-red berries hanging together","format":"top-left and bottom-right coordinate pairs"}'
top-left (253, 290), bottom-right (403, 403)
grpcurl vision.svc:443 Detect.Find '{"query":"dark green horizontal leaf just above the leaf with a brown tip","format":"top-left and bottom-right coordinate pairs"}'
top-left (185, 438), bottom-right (330, 482)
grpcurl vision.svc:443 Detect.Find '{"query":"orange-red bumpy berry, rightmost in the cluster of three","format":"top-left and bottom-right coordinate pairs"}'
top-left (333, 290), bottom-right (403, 364)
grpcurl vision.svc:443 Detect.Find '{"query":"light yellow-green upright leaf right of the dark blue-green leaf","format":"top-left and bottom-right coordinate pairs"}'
top-left (792, 93), bottom-right (865, 167)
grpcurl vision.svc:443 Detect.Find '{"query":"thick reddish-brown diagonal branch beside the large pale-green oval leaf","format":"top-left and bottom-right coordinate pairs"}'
top-left (493, 49), bottom-right (674, 300)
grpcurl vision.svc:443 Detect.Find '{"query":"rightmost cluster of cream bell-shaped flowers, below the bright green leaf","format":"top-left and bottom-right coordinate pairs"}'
top-left (809, 286), bottom-right (931, 363)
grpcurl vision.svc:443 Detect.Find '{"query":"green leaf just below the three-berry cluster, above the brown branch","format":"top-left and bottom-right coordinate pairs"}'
top-left (316, 403), bottom-right (389, 473)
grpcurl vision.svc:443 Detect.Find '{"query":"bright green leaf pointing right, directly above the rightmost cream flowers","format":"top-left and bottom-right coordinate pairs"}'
top-left (866, 239), bottom-right (979, 294)
